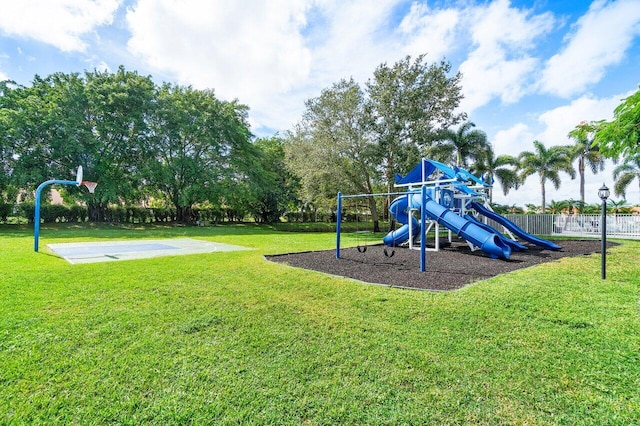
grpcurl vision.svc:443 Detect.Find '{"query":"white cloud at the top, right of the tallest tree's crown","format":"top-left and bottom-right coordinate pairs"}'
top-left (460, 0), bottom-right (555, 113)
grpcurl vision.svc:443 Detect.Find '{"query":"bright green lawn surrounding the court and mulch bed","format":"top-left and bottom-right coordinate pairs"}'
top-left (0, 225), bottom-right (640, 425)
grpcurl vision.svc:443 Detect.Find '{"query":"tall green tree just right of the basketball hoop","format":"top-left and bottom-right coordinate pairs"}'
top-left (83, 66), bottom-right (155, 221)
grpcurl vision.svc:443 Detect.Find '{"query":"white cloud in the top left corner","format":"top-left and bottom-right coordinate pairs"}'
top-left (0, 0), bottom-right (121, 52)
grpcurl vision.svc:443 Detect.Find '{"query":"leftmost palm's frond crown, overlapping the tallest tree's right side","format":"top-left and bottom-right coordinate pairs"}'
top-left (425, 121), bottom-right (489, 168)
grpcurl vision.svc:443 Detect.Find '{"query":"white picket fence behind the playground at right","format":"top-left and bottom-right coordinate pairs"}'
top-left (489, 214), bottom-right (640, 239)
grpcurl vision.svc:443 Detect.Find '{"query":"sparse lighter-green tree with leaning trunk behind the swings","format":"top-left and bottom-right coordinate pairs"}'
top-left (286, 79), bottom-right (379, 232)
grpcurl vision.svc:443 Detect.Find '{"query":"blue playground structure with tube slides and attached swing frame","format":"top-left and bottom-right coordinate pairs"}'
top-left (336, 159), bottom-right (561, 271)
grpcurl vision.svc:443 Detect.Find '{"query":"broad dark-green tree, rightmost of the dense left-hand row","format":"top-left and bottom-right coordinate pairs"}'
top-left (145, 84), bottom-right (257, 222)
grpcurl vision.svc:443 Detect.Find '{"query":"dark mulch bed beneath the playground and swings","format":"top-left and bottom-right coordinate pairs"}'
top-left (265, 240), bottom-right (616, 291)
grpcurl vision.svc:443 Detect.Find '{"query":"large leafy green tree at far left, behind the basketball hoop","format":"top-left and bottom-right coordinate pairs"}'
top-left (0, 73), bottom-right (91, 204)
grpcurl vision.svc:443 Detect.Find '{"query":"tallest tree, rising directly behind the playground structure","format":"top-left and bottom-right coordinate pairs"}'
top-left (366, 55), bottom-right (466, 192)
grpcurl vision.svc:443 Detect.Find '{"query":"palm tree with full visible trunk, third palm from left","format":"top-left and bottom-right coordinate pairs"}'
top-left (518, 141), bottom-right (576, 213)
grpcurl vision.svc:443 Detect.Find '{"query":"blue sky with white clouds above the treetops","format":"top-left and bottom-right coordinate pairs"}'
top-left (0, 0), bottom-right (640, 206)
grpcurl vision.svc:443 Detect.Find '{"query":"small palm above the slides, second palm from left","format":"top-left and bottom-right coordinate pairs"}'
top-left (471, 144), bottom-right (520, 203)
